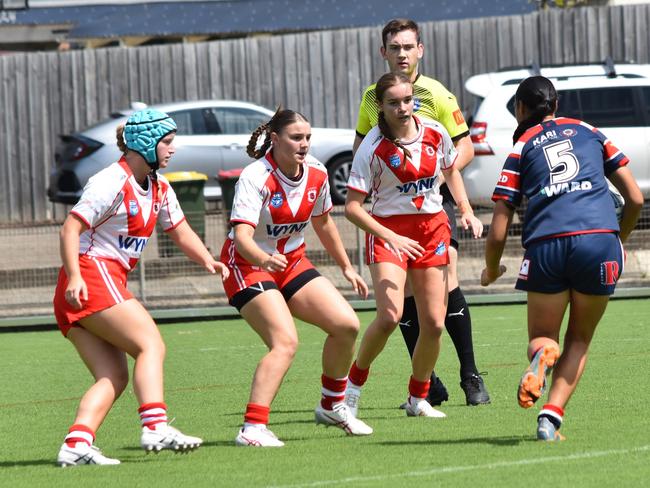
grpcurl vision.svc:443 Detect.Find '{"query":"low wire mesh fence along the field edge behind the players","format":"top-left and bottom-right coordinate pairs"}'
top-left (0, 205), bottom-right (650, 317)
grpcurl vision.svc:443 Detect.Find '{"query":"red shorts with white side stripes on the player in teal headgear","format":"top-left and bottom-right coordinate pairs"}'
top-left (54, 255), bottom-right (133, 336)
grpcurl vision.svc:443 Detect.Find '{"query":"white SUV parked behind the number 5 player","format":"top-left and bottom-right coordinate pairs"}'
top-left (463, 61), bottom-right (650, 206)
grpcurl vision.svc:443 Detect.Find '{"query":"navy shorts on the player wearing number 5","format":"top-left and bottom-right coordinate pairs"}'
top-left (515, 233), bottom-right (623, 295)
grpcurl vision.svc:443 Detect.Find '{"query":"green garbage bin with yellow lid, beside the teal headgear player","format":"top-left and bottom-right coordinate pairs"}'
top-left (158, 171), bottom-right (208, 257)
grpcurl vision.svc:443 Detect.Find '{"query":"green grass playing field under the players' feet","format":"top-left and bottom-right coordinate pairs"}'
top-left (0, 300), bottom-right (650, 487)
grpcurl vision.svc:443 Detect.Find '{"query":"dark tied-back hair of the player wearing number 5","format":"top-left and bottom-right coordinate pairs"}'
top-left (512, 76), bottom-right (557, 144)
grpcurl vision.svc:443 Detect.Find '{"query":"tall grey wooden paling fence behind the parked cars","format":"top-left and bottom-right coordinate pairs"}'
top-left (0, 5), bottom-right (650, 224)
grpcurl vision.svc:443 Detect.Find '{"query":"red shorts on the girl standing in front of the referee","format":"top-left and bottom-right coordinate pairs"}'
top-left (366, 212), bottom-right (451, 269)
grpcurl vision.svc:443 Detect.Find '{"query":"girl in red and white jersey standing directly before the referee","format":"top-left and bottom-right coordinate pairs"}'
top-left (345, 73), bottom-right (483, 417)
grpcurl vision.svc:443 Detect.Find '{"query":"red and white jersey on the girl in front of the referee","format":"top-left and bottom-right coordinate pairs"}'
top-left (347, 117), bottom-right (458, 217)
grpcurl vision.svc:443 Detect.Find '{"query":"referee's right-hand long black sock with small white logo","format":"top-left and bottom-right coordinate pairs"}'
top-left (445, 287), bottom-right (478, 379)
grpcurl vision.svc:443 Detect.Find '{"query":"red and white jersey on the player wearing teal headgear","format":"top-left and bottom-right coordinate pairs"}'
top-left (70, 158), bottom-right (185, 271)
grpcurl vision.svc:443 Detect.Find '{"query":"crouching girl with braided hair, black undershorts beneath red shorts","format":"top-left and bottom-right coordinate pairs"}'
top-left (221, 109), bottom-right (372, 447)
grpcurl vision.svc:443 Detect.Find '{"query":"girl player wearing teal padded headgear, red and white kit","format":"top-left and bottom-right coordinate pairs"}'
top-left (54, 109), bottom-right (228, 466)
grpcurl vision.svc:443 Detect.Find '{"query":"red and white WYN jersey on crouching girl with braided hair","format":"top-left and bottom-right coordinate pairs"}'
top-left (228, 151), bottom-right (332, 254)
